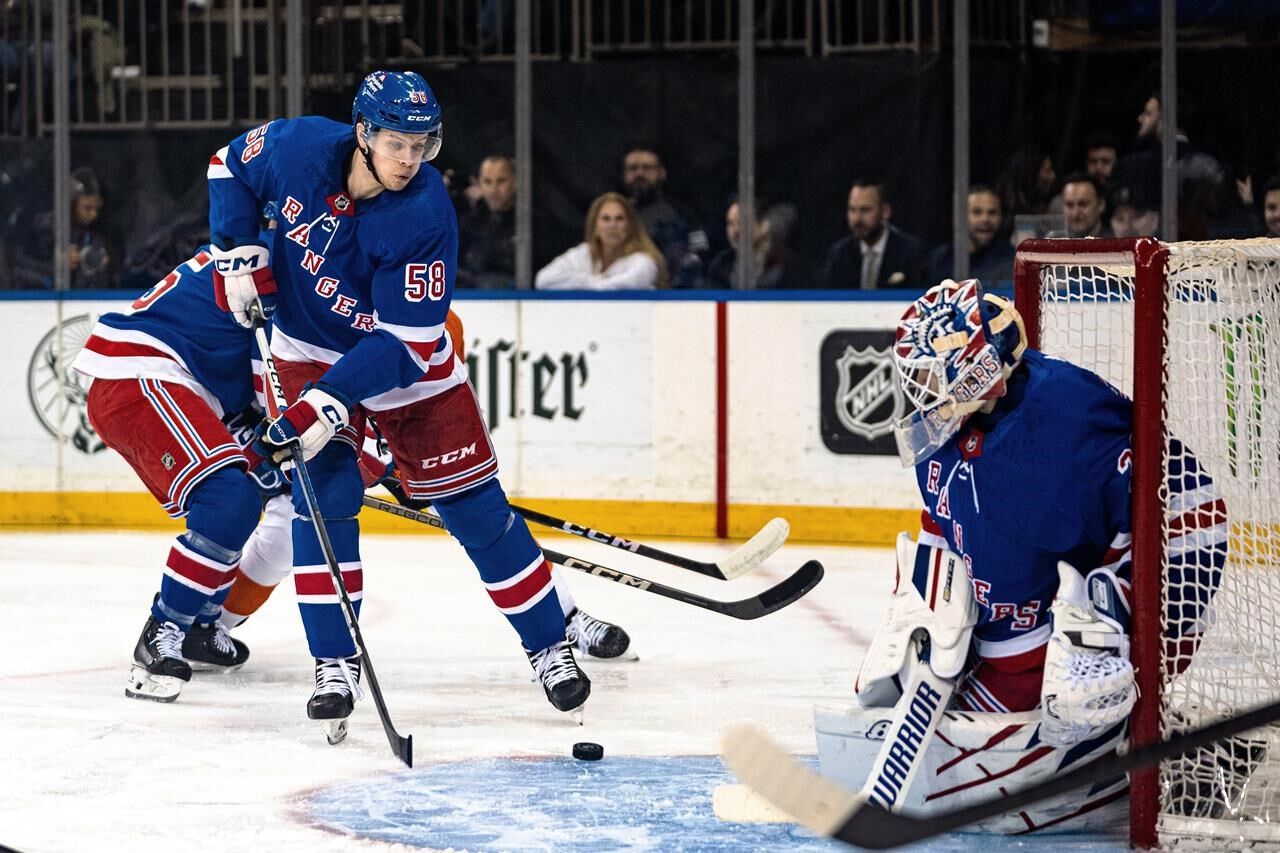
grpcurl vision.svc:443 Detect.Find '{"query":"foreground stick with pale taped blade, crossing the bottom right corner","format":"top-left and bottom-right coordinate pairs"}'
top-left (723, 702), bottom-right (1280, 850)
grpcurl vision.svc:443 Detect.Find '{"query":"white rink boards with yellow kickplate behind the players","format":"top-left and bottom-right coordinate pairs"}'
top-left (0, 293), bottom-right (918, 544)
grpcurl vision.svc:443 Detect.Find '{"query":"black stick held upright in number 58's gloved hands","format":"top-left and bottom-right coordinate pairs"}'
top-left (253, 309), bottom-right (413, 767)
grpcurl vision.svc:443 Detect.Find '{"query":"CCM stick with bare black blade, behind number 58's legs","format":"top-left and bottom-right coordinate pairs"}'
top-left (365, 494), bottom-right (823, 619)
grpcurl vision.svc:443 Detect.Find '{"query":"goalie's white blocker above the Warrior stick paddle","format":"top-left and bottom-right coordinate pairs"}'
top-left (854, 533), bottom-right (978, 708)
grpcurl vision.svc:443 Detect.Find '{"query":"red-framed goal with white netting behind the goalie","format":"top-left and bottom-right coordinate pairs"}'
top-left (1016, 238), bottom-right (1280, 847)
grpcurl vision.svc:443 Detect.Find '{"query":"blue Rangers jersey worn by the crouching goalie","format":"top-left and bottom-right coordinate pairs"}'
top-left (915, 350), bottom-right (1226, 670)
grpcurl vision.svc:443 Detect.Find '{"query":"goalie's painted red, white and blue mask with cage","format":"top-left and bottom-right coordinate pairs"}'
top-left (893, 279), bottom-right (1027, 465)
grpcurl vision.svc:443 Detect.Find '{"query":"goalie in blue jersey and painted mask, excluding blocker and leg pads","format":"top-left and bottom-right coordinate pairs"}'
top-left (856, 279), bottom-right (1228, 747)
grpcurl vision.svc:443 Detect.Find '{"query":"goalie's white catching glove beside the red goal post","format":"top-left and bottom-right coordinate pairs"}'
top-left (1041, 562), bottom-right (1138, 747)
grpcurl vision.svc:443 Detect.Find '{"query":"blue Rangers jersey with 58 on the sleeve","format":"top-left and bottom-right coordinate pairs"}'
top-left (209, 117), bottom-right (466, 411)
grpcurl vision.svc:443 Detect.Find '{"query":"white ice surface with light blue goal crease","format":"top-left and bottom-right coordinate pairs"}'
top-left (0, 528), bottom-right (1121, 853)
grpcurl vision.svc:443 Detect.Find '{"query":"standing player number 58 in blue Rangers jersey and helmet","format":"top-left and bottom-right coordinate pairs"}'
top-left (209, 72), bottom-right (606, 733)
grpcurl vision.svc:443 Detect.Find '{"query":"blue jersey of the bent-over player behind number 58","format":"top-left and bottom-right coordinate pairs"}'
top-left (72, 247), bottom-right (256, 418)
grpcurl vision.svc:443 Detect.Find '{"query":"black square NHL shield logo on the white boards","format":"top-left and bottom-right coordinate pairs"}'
top-left (819, 329), bottom-right (909, 456)
